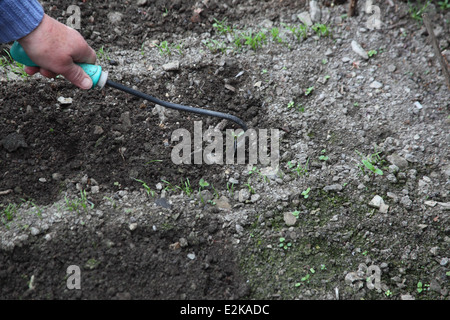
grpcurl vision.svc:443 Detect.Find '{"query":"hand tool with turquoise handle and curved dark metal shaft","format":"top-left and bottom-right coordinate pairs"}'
top-left (11, 41), bottom-right (247, 131)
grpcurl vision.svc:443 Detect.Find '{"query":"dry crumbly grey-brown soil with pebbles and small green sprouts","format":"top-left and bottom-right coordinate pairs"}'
top-left (0, 0), bottom-right (450, 300)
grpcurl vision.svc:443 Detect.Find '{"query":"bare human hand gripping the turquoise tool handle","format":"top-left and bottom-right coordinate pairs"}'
top-left (18, 14), bottom-right (97, 89)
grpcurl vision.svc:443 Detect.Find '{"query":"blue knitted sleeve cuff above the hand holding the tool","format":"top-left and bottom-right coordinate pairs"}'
top-left (0, 0), bottom-right (44, 43)
